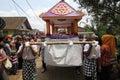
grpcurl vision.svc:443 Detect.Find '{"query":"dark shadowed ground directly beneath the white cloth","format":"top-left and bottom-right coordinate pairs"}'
top-left (36, 66), bottom-right (83, 80)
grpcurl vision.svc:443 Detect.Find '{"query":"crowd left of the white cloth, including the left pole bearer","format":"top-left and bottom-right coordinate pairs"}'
top-left (0, 36), bottom-right (38, 80)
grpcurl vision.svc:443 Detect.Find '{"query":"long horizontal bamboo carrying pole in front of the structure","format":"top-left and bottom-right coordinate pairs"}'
top-left (30, 41), bottom-right (93, 45)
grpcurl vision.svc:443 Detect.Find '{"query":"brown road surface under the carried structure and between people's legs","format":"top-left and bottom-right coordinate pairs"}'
top-left (10, 58), bottom-right (83, 80)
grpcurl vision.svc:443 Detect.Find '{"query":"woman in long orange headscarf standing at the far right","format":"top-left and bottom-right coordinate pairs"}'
top-left (100, 34), bottom-right (116, 80)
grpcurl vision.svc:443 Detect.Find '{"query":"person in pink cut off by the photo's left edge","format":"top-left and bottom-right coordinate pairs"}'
top-left (0, 36), bottom-right (9, 80)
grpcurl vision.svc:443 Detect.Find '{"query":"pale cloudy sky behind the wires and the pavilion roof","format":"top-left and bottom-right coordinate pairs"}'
top-left (0, 0), bottom-right (90, 31)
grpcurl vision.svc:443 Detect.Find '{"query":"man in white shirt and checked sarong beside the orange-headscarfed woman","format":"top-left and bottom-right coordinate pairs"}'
top-left (83, 36), bottom-right (101, 80)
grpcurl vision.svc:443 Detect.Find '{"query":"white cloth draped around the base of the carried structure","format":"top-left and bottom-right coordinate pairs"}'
top-left (44, 39), bottom-right (82, 67)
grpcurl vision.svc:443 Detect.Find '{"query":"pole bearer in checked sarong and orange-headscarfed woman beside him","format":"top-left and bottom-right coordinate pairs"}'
top-left (83, 34), bottom-right (116, 80)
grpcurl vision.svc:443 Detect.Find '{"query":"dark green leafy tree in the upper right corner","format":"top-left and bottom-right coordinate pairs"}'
top-left (74, 0), bottom-right (120, 35)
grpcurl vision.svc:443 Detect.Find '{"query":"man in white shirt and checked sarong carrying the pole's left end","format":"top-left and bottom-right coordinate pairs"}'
top-left (17, 36), bottom-right (38, 80)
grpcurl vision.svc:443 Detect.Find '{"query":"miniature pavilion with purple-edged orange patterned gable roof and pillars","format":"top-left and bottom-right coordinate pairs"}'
top-left (40, 0), bottom-right (84, 34)
